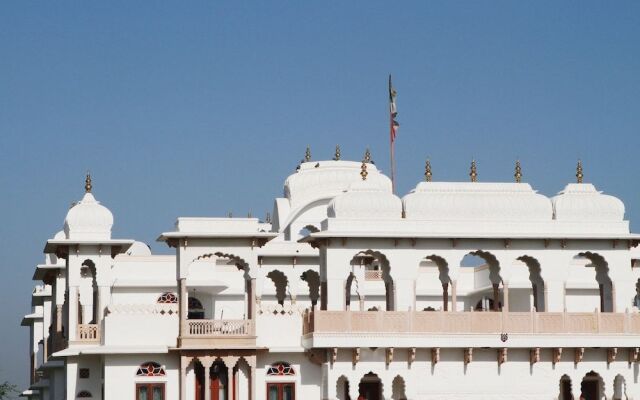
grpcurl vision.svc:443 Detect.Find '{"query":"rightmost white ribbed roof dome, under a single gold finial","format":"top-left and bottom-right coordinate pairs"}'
top-left (551, 183), bottom-right (624, 222)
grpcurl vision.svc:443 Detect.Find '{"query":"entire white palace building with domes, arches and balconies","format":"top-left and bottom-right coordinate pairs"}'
top-left (22, 151), bottom-right (640, 400)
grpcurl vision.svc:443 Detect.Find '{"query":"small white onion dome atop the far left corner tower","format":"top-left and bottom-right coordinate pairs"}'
top-left (64, 193), bottom-right (113, 240)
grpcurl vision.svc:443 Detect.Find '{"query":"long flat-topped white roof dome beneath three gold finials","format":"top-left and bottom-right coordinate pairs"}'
top-left (402, 182), bottom-right (553, 221)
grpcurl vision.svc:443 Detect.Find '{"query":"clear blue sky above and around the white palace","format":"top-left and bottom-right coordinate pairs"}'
top-left (0, 1), bottom-right (640, 385)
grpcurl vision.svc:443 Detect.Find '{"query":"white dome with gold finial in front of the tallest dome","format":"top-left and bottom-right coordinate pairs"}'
top-left (327, 179), bottom-right (402, 219)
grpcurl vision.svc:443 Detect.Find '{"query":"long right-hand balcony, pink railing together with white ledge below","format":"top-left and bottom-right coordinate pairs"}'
top-left (303, 310), bottom-right (640, 347)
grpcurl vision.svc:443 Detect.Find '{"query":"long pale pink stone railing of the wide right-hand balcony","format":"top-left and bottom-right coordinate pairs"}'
top-left (303, 310), bottom-right (640, 334)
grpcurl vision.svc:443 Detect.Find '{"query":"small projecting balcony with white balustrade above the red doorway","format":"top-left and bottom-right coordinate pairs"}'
top-left (179, 319), bottom-right (256, 349)
